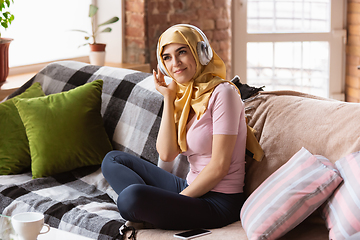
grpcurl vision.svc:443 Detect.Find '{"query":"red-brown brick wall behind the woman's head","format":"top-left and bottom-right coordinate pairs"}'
top-left (124, 0), bottom-right (231, 77)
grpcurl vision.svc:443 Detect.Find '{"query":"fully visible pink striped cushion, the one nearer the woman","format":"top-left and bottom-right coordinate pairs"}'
top-left (240, 148), bottom-right (342, 240)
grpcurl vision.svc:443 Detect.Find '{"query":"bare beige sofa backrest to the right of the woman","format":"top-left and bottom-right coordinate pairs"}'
top-left (244, 91), bottom-right (360, 196)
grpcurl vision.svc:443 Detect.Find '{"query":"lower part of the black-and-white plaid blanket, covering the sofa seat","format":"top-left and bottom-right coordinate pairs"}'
top-left (0, 166), bottom-right (125, 239)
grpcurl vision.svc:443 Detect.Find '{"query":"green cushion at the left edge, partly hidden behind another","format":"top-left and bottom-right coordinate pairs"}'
top-left (0, 83), bottom-right (45, 175)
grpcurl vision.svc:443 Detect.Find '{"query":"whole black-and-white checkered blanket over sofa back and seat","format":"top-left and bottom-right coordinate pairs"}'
top-left (0, 61), bottom-right (163, 239)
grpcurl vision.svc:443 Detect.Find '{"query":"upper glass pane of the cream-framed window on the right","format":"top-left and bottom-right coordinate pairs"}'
top-left (247, 0), bottom-right (331, 33)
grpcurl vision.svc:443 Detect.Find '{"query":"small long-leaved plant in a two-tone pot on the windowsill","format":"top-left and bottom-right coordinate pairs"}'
top-left (73, 4), bottom-right (119, 66)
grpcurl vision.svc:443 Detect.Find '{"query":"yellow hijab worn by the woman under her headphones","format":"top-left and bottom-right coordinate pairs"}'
top-left (157, 25), bottom-right (262, 161)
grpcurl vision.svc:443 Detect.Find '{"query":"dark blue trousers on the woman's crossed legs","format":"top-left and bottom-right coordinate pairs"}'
top-left (102, 151), bottom-right (244, 230)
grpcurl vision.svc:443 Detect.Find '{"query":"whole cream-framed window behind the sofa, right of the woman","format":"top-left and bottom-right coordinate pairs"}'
top-left (233, 0), bottom-right (346, 100)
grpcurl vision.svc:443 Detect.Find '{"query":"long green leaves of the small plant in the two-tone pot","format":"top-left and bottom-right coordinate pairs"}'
top-left (72, 4), bottom-right (119, 46)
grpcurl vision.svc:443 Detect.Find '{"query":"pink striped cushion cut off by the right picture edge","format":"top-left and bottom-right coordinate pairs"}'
top-left (322, 152), bottom-right (360, 240)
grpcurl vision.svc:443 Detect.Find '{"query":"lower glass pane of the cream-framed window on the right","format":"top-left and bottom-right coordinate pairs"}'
top-left (247, 41), bottom-right (330, 97)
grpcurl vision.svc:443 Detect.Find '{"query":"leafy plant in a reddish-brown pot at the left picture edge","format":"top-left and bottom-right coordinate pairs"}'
top-left (0, 0), bottom-right (14, 83)
